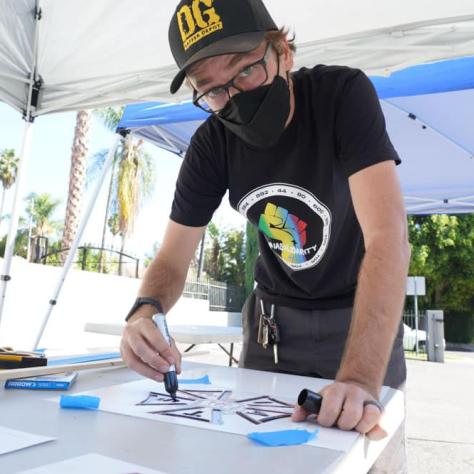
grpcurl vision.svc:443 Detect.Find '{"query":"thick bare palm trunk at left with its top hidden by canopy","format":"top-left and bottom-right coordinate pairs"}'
top-left (61, 110), bottom-right (91, 264)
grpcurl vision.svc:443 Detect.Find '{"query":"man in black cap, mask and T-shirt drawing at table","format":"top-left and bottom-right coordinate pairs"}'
top-left (121, 0), bottom-right (409, 473)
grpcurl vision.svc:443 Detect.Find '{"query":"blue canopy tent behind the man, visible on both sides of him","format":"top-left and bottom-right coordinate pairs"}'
top-left (119, 57), bottom-right (474, 214)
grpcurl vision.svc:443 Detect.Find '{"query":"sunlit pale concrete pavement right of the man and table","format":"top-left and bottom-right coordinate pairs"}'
top-left (407, 352), bottom-right (474, 474)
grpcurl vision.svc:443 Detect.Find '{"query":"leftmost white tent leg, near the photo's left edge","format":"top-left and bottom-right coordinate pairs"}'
top-left (0, 120), bottom-right (33, 336)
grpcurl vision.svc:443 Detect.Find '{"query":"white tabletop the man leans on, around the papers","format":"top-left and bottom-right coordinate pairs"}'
top-left (0, 362), bottom-right (403, 474)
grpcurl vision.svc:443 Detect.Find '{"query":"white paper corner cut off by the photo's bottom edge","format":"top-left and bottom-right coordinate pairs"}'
top-left (19, 453), bottom-right (164, 474)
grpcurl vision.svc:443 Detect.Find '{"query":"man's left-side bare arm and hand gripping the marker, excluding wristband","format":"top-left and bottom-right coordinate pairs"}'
top-left (120, 220), bottom-right (205, 381)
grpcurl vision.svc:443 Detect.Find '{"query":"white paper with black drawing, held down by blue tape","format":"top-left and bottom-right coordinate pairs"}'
top-left (63, 379), bottom-right (359, 452)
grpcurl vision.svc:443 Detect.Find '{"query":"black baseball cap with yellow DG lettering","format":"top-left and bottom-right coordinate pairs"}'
top-left (168, 0), bottom-right (278, 94)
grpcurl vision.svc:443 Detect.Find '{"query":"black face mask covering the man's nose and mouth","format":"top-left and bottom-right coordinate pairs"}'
top-left (217, 75), bottom-right (290, 148)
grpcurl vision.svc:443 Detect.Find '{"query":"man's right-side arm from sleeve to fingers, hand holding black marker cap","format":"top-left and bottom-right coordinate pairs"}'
top-left (293, 161), bottom-right (410, 439)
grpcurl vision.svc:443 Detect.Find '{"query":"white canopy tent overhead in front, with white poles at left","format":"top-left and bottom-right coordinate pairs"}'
top-left (0, 0), bottom-right (474, 344)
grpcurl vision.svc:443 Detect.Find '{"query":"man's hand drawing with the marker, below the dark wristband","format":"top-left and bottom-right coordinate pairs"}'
top-left (120, 315), bottom-right (181, 382)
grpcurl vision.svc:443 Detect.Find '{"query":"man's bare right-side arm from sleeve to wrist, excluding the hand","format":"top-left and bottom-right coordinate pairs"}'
top-left (337, 161), bottom-right (410, 397)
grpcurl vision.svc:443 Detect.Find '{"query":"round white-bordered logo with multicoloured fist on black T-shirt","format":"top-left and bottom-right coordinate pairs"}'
top-left (237, 183), bottom-right (331, 270)
